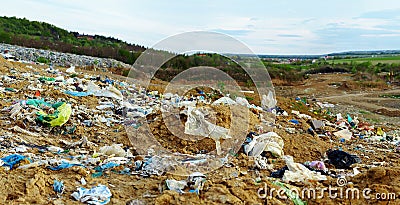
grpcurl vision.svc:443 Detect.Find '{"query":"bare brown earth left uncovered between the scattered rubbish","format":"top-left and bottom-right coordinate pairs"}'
top-left (0, 57), bottom-right (400, 204)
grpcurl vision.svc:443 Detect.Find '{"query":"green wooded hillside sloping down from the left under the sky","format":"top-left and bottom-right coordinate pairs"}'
top-left (0, 17), bottom-right (145, 64)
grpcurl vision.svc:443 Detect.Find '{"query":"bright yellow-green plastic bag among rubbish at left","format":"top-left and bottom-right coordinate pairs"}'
top-left (36, 103), bottom-right (72, 127)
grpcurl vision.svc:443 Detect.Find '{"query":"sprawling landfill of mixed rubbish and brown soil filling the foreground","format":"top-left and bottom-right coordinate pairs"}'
top-left (0, 54), bottom-right (400, 205)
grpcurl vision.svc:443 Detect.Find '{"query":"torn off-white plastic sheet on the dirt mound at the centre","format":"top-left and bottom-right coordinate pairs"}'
top-left (185, 107), bottom-right (231, 154)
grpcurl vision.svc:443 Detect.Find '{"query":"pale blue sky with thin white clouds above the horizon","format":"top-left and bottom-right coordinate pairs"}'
top-left (0, 0), bottom-right (400, 54)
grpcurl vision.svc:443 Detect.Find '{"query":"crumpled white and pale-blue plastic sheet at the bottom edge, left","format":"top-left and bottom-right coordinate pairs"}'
top-left (71, 184), bottom-right (112, 205)
